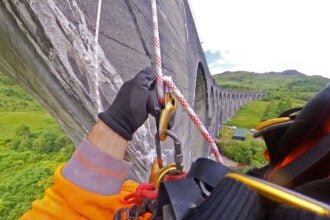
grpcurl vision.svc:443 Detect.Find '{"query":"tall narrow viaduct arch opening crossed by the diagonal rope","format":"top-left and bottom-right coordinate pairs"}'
top-left (192, 63), bottom-right (209, 159)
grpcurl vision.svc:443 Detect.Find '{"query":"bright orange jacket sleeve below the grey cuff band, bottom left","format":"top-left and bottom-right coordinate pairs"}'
top-left (22, 165), bottom-right (138, 220)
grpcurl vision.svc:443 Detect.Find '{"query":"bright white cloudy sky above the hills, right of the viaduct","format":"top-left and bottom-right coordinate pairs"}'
top-left (189, 0), bottom-right (330, 78)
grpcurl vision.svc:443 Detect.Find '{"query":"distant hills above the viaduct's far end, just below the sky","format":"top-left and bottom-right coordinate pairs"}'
top-left (213, 70), bottom-right (330, 101)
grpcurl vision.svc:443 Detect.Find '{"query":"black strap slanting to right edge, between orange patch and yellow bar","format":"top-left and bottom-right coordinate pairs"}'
top-left (269, 134), bottom-right (330, 187)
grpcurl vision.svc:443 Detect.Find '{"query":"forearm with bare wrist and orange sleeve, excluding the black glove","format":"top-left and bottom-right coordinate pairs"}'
top-left (22, 121), bottom-right (138, 220)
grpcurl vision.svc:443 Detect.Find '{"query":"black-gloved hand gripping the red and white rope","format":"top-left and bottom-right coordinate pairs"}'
top-left (99, 67), bottom-right (158, 140)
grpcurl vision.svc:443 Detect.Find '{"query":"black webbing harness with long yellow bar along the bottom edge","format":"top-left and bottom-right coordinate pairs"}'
top-left (156, 158), bottom-right (330, 219)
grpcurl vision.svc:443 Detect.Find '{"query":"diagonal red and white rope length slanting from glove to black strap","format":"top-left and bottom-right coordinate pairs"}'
top-left (163, 76), bottom-right (224, 164)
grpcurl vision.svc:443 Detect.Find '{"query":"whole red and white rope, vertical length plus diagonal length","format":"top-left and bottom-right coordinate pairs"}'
top-left (151, 0), bottom-right (224, 164)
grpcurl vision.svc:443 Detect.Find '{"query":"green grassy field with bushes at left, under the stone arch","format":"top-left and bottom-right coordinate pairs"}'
top-left (0, 73), bottom-right (73, 220)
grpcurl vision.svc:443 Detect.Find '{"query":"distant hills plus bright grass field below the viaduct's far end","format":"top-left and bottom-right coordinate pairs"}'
top-left (213, 70), bottom-right (330, 128)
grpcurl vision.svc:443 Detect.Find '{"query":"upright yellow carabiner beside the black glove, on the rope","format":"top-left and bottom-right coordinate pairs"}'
top-left (158, 93), bottom-right (177, 141)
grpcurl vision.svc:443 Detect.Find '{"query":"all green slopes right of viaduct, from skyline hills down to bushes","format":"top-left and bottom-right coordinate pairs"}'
top-left (214, 70), bottom-right (330, 167)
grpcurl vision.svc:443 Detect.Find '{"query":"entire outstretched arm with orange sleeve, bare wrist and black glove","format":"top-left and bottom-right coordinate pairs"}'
top-left (22, 69), bottom-right (155, 219)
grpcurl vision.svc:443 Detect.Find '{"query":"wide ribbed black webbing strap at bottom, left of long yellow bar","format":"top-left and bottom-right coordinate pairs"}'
top-left (185, 177), bottom-right (265, 220)
